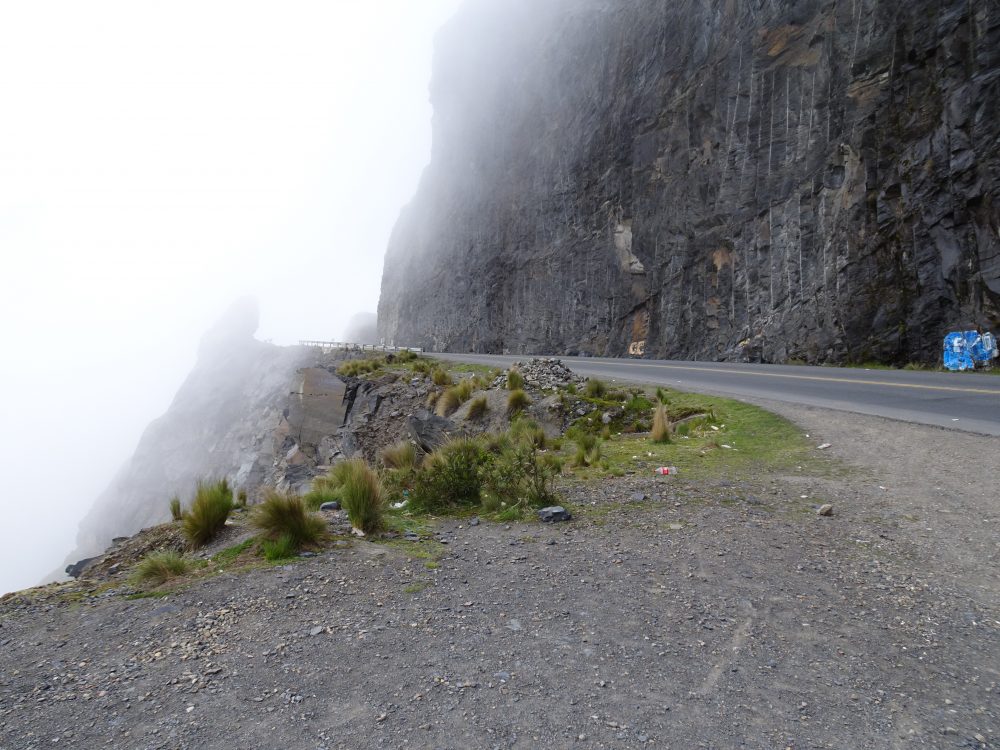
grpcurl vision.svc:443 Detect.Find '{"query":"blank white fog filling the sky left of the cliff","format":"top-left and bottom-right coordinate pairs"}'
top-left (0, 0), bottom-right (458, 592)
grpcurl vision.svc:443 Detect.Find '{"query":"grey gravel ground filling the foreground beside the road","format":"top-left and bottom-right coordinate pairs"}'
top-left (0, 405), bottom-right (1000, 750)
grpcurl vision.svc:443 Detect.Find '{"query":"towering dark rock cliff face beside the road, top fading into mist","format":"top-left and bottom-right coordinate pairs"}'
top-left (379, 0), bottom-right (1000, 362)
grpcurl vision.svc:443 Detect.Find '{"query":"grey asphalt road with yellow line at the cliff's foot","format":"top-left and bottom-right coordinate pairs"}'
top-left (433, 354), bottom-right (1000, 435)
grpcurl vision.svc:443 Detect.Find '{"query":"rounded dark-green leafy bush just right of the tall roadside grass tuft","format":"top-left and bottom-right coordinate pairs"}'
top-left (410, 438), bottom-right (490, 513)
